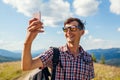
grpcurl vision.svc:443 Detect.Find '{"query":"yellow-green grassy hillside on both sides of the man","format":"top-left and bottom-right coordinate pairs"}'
top-left (0, 61), bottom-right (120, 80)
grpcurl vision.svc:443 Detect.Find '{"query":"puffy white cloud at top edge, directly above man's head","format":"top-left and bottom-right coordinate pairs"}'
top-left (73, 0), bottom-right (100, 17)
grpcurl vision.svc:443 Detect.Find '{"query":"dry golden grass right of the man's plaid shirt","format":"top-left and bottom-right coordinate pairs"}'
top-left (94, 64), bottom-right (120, 80)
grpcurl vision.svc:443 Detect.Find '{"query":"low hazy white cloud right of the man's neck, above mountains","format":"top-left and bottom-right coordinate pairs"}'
top-left (81, 36), bottom-right (115, 50)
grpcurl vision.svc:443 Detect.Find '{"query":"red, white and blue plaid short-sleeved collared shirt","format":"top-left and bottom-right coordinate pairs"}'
top-left (40, 45), bottom-right (94, 80)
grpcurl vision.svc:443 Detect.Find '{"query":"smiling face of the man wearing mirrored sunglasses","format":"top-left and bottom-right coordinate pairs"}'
top-left (64, 21), bottom-right (84, 44)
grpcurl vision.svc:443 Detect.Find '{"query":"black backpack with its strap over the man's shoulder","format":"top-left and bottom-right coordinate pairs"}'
top-left (29, 47), bottom-right (61, 80)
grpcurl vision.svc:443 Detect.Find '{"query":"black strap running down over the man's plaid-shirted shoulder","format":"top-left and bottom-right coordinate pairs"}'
top-left (51, 47), bottom-right (60, 80)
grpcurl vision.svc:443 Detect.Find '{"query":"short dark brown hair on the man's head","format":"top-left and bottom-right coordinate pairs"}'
top-left (64, 17), bottom-right (85, 30)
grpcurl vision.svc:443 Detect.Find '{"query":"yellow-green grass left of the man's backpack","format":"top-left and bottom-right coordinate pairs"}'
top-left (0, 62), bottom-right (28, 80)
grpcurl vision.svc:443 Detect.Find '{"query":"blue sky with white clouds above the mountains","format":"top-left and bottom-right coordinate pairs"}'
top-left (0, 0), bottom-right (120, 51)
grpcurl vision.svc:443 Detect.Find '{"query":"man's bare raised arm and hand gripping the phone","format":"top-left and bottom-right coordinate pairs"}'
top-left (21, 18), bottom-right (44, 71)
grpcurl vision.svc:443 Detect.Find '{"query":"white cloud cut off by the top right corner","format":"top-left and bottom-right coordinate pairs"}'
top-left (110, 0), bottom-right (120, 15)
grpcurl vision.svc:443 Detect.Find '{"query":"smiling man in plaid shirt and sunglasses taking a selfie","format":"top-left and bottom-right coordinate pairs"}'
top-left (22, 18), bottom-right (94, 80)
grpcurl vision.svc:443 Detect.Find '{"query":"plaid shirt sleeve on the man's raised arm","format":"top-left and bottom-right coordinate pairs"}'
top-left (39, 48), bottom-right (53, 68)
